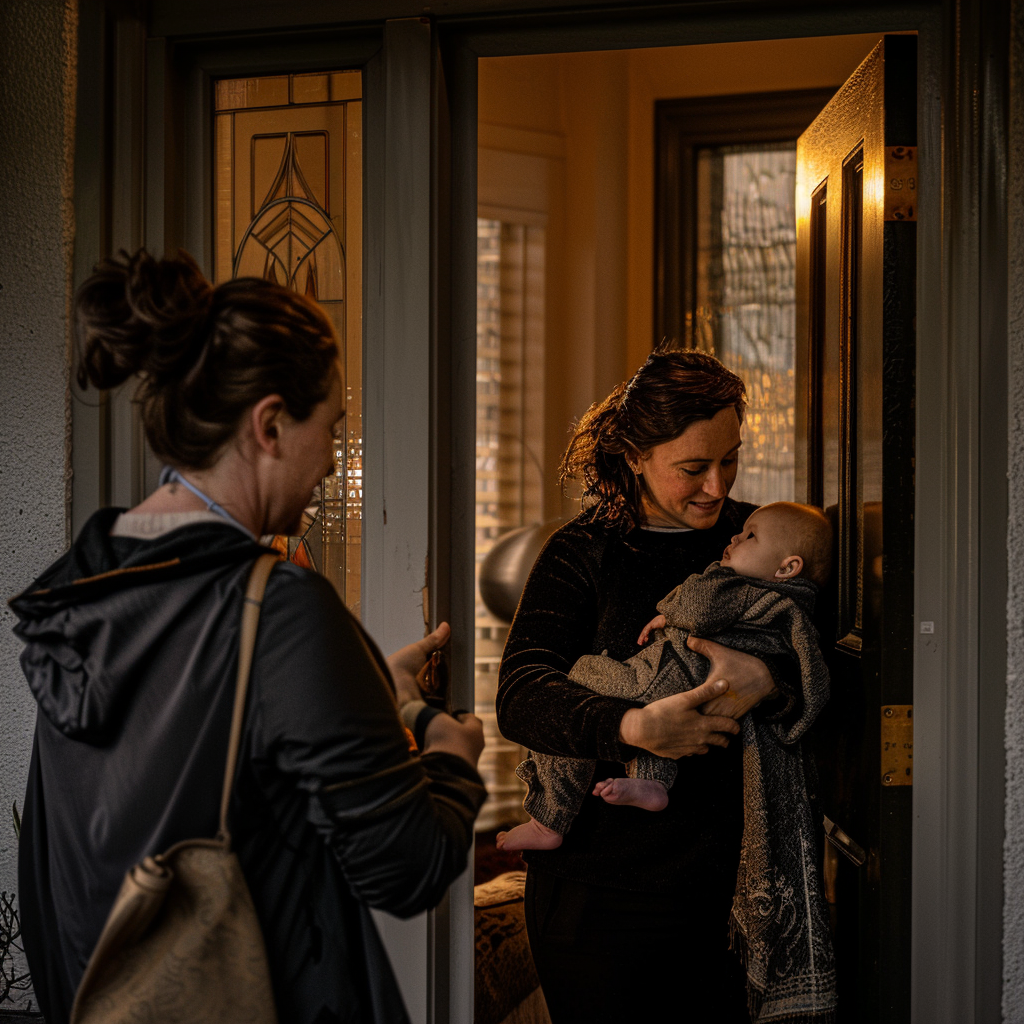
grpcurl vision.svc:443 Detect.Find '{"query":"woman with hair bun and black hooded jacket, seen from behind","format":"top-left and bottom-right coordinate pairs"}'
top-left (11, 251), bottom-right (485, 1024)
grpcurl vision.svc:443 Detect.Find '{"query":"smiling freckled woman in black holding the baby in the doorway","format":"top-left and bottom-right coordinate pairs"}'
top-left (498, 351), bottom-right (782, 1024)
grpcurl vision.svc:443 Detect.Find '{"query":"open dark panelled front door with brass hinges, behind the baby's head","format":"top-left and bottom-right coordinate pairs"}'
top-left (797, 36), bottom-right (927, 1024)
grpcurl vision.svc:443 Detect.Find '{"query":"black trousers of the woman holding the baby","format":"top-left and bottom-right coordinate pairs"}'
top-left (524, 868), bottom-right (750, 1024)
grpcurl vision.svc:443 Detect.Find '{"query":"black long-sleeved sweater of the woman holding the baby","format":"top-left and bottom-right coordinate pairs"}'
top-left (498, 500), bottom-right (755, 893)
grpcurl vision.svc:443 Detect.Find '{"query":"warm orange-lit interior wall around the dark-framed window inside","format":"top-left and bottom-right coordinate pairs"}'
top-left (479, 35), bottom-right (879, 515)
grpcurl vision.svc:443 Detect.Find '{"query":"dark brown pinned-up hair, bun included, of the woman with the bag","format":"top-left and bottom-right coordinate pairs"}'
top-left (75, 249), bottom-right (338, 469)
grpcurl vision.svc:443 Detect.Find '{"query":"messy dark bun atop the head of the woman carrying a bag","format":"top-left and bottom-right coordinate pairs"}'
top-left (75, 249), bottom-right (213, 388)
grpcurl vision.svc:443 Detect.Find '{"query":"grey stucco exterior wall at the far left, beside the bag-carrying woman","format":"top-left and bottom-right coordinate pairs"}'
top-left (0, 0), bottom-right (77, 1002)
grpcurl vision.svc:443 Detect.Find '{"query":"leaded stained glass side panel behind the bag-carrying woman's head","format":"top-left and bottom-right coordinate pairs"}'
top-left (214, 72), bottom-right (362, 614)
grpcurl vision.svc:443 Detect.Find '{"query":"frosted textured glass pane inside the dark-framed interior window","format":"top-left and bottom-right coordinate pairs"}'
top-left (693, 143), bottom-right (797, 505)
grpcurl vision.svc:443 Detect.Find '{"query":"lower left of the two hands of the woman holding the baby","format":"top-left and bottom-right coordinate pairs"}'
top-left (618, 679), bottom-right (741, 760)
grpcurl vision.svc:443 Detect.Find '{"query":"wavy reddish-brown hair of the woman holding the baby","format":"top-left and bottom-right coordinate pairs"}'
top-left (560, 350), bottom-right (746, 526)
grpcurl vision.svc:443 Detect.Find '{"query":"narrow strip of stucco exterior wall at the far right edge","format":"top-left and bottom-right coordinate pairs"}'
top-left (1002, 0), bottom-right (1024, 1024)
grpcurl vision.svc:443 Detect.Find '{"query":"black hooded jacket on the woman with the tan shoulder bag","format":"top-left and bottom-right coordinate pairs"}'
top-left (11, 509), bottom-right (484, 1024)
